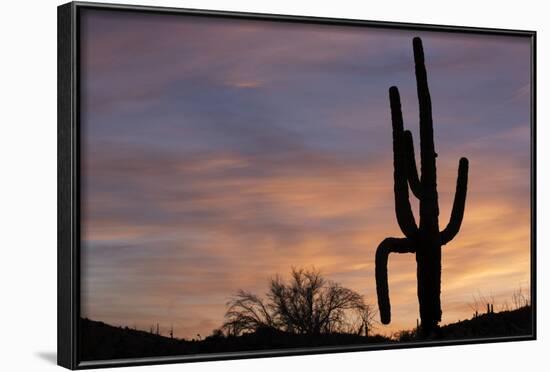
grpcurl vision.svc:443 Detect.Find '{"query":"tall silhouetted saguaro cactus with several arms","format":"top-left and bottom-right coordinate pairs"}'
top-left (376, 37), bottom-right (468, 336)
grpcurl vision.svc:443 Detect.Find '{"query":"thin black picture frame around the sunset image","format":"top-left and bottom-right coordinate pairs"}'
top-left (57, 2), bottom-right (537, 369)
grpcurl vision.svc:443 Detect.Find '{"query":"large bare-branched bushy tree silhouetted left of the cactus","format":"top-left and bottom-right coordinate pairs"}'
top-left (223, 268), bottom-right (374, 335)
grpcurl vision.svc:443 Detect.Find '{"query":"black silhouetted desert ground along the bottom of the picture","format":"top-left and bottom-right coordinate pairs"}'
top-left (80, 307), bottom-right (532, 361)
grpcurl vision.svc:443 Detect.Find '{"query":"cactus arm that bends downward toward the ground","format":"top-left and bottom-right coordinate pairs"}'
top-left (375, 238), bottom-right (416, 324)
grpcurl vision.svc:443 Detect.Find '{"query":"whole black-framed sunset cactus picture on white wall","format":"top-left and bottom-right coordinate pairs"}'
top-left (58, 2), bottom-right (536, 369)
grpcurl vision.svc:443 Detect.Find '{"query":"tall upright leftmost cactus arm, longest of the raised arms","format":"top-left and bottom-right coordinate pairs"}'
top-left (390, 87), bottom-right (418, 238)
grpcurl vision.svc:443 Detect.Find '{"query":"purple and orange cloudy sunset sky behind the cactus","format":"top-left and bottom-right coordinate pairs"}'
top-left (81, 10), bottom-right (531, 338)
